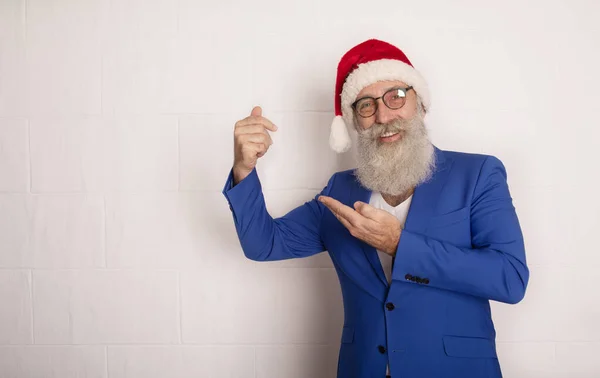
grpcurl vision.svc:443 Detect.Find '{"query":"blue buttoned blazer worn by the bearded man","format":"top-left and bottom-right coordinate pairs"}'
top-left (223, 147), bottom-right (529, 378)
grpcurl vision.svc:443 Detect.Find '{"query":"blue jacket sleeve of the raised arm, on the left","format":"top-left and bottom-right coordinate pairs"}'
top-left (223, 168), bottom-right (335, 261)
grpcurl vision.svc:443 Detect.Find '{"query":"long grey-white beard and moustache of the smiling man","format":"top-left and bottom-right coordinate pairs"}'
top-left (356, 112), bottom-right (435, 195)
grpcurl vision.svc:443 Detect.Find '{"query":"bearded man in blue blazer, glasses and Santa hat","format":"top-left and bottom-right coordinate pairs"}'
top-left (223, 39), bottom-right (529, 378)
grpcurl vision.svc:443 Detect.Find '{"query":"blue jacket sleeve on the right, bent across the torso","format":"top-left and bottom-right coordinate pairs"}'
top-left (393, 156), bottom-right (529, 304)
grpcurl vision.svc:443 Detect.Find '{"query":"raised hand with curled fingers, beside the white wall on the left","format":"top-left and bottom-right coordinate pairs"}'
top-left (233, 106), bottom-right (277, 185)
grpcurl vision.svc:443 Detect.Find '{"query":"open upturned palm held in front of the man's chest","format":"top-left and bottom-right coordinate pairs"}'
top-left (318, 196), bottom-right (402, 256)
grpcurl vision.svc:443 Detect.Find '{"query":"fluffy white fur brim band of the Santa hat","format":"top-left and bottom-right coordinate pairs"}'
top-left (334, 59), bottom-right (431, 131)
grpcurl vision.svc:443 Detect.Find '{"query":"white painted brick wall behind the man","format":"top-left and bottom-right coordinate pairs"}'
top-left (0, 0), bottom-right (600, 378)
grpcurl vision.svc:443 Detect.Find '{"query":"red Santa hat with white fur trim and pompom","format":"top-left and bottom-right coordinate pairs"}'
top-left (329, 39), bottom-right (430, 153)
